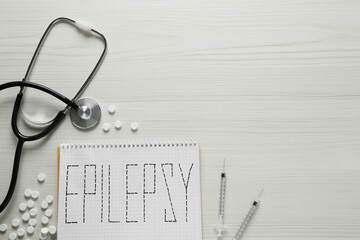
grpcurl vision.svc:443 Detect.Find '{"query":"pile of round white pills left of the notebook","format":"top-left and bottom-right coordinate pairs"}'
top-left (0, 173), bottom-right (56, 240)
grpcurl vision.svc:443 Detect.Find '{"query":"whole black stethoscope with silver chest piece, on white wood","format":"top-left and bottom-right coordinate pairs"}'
top-left (0, 17), bottom-right (107, 213)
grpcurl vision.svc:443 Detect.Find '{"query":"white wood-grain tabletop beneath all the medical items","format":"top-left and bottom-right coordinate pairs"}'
top-left (0, 0), bottom-right (360, 240)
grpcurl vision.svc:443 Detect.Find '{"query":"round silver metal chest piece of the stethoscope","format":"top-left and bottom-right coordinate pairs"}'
top-left (70, 98), bottom-right (101, 130)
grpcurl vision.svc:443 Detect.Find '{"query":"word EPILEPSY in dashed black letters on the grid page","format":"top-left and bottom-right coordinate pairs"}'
top-left (64, 163), bottom-right (194, 224)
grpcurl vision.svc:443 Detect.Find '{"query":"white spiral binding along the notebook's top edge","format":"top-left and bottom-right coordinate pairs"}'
top-left (60, 139), bottom-right (198, 149)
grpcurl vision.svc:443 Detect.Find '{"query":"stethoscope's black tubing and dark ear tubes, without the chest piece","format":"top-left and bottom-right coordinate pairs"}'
top-left (0, 17), bottom-right (107, 213)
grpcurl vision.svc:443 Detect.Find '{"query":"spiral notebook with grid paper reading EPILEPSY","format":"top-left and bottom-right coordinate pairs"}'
top-left (57, 141), bottom-right (202, 240)
